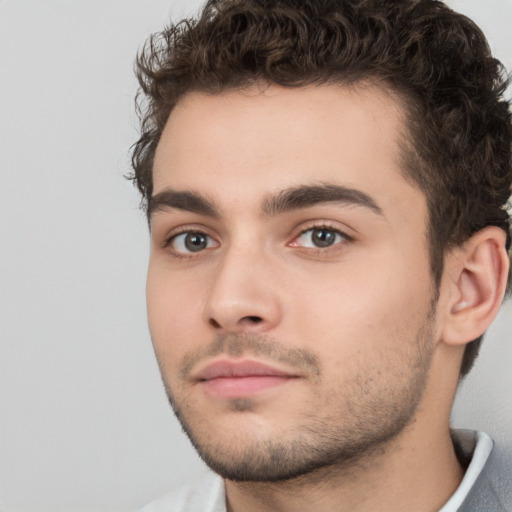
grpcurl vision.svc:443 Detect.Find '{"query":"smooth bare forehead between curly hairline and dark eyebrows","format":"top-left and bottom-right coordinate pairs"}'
top-left (153, 85), bottom-right (424, 221)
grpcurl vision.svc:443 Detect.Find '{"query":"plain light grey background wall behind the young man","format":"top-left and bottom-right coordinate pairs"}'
top-left (0, 0), bottom-right (512, 512)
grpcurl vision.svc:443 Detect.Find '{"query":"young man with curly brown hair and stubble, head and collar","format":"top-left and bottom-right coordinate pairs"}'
top-left (133, 0), bottom-right (512, 512)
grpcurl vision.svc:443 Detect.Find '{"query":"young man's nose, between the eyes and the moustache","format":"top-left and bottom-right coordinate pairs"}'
top-left (204, 247), bottom-right (282, 334)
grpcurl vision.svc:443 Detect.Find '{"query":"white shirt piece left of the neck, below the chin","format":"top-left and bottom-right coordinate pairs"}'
top-left (138, 471), bottom-right (226, 512)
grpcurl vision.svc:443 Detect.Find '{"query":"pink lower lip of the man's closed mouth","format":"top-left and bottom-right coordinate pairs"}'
top-left (201, 375), bottom-right (293, 398)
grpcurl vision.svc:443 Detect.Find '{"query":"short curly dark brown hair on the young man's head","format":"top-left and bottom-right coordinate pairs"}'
top-left (131, 0), bottom-right (512, 376)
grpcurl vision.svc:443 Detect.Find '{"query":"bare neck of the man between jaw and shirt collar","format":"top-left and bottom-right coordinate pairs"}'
top-left (226, 422), bottom-right (463, 512)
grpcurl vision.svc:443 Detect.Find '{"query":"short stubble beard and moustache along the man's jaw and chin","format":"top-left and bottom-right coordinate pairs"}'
top-left (162, 310), bottom-right (434, 482)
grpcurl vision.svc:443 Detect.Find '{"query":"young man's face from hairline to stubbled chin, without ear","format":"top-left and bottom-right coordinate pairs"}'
top-left (147, 85), bottom-right (435, 481)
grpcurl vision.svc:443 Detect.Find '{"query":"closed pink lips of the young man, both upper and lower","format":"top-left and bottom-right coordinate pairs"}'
top-left (195, 360), bottom-right (299, 398)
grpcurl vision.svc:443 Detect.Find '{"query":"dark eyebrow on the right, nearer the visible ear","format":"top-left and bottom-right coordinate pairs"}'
top-left (263, 184), bottom-right (384, 217)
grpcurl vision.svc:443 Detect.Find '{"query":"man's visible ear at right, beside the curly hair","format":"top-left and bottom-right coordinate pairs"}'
top-left (441, 226), bottom-right (510, 345)
